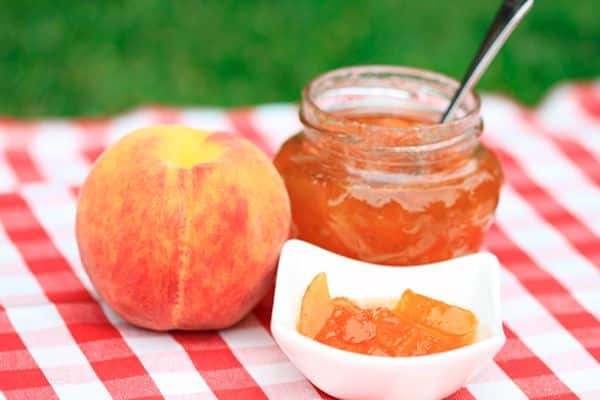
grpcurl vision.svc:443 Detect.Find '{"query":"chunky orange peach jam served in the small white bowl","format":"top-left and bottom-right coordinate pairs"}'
top-left (298, 273), bottom-right (478, 357)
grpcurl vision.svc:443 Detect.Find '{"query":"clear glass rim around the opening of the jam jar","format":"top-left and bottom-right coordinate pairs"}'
top-left (300, 65), bottom-right (481, 151)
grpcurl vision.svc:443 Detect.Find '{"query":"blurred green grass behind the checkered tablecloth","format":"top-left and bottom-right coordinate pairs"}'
top-left (0, 0), bottom-right (600, 117)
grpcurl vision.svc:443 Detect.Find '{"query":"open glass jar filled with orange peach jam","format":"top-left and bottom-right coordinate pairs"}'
top-left (275, 66), bottom-right (502, 265)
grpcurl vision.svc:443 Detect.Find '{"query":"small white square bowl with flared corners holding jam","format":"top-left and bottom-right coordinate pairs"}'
top-left (271, 240), bottom-right (505, 399)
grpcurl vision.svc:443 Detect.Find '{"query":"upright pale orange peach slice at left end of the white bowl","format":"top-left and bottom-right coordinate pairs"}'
top-left (298, 272), bottom-right (333, 338)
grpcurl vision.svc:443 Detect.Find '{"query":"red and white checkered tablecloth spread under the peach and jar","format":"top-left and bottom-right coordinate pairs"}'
top-left (0, 82), bottom-right (600, 400)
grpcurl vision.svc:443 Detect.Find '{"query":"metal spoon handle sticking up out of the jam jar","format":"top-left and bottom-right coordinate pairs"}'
top-left (441, 0), bottom-right (533, 122)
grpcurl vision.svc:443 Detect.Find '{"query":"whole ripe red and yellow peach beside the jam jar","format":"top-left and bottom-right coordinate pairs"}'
top-left (76, 126), bottom-right (291, 330)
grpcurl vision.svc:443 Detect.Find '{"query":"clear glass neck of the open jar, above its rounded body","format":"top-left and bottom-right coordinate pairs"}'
top-left (300, 66), bottom-right (482, 171)
